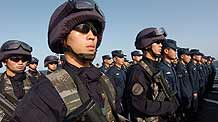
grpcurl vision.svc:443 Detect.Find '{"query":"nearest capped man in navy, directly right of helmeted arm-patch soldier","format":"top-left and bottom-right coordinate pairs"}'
top-left (160, 39), bottom-right (181, 101)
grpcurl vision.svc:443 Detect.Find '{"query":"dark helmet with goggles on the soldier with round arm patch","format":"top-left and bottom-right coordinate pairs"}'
top-left (135, 27), bottom-right (167, 50)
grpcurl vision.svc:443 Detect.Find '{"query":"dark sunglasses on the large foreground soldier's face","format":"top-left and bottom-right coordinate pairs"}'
top-left (73, 23), bottom-right (98, 36)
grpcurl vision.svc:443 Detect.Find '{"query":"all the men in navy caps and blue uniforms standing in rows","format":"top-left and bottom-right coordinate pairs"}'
top-left (96, 39), bottom-right (216, 121)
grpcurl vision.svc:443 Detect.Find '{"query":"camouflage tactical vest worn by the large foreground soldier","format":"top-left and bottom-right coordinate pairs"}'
top-left (47, 69), bottom-right (115, 122)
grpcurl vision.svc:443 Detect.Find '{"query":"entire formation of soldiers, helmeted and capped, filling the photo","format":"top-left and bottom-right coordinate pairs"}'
top-left (0, 0), bottom-right (215, 122)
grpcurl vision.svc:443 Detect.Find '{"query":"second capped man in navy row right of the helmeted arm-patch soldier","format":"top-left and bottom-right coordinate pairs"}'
top-left (176, 48), bottom-right (193, 119)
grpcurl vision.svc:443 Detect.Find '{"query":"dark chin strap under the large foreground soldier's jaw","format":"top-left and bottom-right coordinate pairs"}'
top-left (64, 46), bottom-right (96, 63)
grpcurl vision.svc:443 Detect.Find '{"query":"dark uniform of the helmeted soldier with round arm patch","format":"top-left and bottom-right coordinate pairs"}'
top-left (126, 58), bottom-right (177, 121)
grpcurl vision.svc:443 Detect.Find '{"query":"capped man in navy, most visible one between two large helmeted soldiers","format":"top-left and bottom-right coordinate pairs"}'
top-left (106, 50), bottom-right (126, 114)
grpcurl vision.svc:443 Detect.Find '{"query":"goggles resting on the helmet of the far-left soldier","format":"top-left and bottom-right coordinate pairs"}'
top-left (1, 40), bottom-right (32, 52)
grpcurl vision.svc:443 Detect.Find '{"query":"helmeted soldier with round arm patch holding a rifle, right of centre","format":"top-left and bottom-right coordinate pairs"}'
top-left (125, 28), bottom-right (177, 122)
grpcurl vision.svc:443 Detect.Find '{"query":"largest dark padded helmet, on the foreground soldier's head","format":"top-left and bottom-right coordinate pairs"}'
top-left (48, 0), bottom-right (105, 54)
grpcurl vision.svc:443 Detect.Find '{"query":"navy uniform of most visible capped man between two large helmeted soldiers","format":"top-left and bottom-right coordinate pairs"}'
top-left (106, 65), bottom-right (126, 113)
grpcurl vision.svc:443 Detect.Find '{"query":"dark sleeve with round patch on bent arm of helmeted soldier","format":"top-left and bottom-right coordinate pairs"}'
top-left (127, 67), bottom-right (175, 115)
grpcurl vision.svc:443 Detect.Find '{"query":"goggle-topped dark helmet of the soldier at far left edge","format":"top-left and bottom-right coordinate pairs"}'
top-left (0, 40), bottom-right (32, 61)
